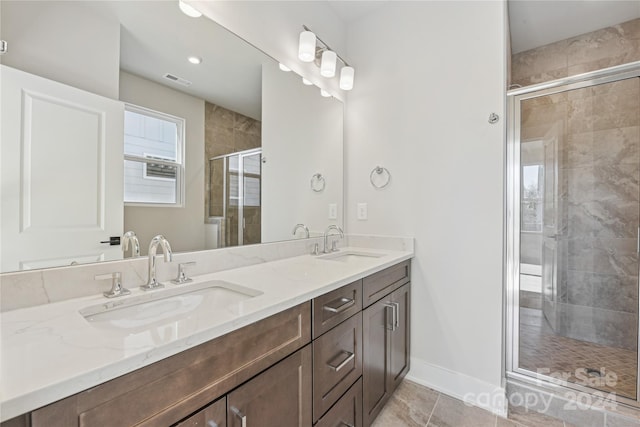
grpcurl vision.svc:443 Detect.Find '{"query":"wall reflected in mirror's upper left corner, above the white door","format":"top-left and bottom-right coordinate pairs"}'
top-left (0, 0), bottom-right (120, 99)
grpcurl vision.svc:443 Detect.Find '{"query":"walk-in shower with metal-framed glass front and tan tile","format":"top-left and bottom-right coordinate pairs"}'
top-left (507, 63), bottom-right (640, 406)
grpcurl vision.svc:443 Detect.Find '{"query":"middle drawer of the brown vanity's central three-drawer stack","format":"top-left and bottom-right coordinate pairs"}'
top-left (313, 312), bottom-right (362, 421)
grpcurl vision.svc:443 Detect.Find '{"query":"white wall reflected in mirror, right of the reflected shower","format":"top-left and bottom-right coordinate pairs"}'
top-left (262, 64), bottom-right (344, 241)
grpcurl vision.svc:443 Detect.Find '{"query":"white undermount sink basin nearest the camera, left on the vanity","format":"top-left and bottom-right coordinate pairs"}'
top-left (80, 280), bottom-right (262, 329)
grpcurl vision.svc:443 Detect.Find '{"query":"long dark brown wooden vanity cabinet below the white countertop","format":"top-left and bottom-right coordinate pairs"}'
top-left (0, 261), bottom-right (410, 427)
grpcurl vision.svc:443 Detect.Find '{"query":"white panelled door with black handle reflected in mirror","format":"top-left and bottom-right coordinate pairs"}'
top-left (0, 65), bottom-right (124, 272)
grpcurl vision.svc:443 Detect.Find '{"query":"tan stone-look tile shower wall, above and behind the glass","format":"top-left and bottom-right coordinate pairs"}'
top-left (512, 19), bottom-right (640, 349)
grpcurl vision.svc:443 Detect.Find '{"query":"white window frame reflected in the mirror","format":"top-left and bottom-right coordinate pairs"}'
top-left (122, 103), bottom-right (186, 208)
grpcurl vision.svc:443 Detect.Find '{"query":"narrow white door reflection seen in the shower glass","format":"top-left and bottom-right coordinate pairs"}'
top-left (542, 127), bottom-right (558, 330)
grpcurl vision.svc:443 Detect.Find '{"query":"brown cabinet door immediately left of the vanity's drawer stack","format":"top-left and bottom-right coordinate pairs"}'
top-left (227, 346), bottom-right (312, 427)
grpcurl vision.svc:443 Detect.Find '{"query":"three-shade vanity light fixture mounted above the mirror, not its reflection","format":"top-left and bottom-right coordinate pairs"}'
top-left (298, 25), bottom-right (355, 90)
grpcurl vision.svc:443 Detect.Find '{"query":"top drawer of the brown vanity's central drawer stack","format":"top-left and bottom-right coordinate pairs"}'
top-left (312, 280), bottom-right (362, 339)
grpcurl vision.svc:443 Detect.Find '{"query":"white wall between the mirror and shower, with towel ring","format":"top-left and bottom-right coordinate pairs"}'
top-left (345, 1), bottom-right (506, 412)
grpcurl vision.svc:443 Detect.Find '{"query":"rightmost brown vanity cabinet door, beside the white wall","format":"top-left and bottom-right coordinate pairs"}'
top-left (388, 284), bottom-right (411, 393)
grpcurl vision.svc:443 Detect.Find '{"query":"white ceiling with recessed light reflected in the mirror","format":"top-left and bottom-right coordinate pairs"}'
top-left (83, 0), bottom-right (266, 120)
